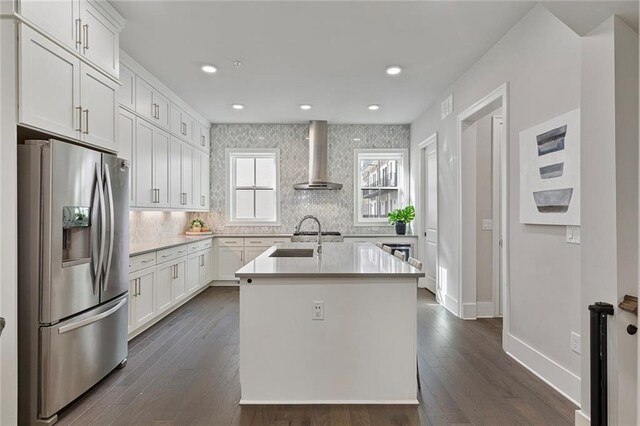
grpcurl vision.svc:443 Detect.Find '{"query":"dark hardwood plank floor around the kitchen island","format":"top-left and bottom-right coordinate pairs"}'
top-left (53, 287), bottom-right (576, 426)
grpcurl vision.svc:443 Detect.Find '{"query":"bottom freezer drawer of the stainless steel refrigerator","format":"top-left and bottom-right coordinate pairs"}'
top-left (39, 294), bottom-right (128, 418)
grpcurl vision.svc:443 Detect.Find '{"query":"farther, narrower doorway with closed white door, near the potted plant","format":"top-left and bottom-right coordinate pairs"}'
top-left (419, 133), bottom-right (442, 303)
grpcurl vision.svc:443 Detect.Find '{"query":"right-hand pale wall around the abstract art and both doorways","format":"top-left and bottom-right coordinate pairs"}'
top-left (411, 6), bottom-right (581, 401)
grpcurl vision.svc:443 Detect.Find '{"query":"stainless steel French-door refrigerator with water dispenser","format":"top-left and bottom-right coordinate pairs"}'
top-left (18, 140), bottom-right (129, 424)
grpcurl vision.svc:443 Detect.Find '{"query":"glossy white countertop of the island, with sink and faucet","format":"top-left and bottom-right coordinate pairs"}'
top-left (236, 242), bottom-right (425, 278)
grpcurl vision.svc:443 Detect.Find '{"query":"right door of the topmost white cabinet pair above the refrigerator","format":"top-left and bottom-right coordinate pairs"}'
top-left (80, 0), bottom-right (120, 77)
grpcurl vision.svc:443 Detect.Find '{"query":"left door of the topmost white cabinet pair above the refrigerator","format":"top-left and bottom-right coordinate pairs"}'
top-left (18, 0), bottom-right (80, 50)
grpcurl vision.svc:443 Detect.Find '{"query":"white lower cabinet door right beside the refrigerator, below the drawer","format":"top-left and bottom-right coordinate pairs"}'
top-left (129, 266), bottom-right (156, 331)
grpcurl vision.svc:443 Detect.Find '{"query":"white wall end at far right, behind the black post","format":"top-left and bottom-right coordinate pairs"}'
top-left (581, 18), bottom-right (638, 425)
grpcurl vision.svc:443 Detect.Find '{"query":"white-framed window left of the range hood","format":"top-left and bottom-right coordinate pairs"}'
top-left (226, 148), bottom-right (280, 226)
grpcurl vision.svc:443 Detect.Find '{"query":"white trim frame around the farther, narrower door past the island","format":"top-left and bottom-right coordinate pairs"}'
top-left (418, 132), bottom-right (444, 296)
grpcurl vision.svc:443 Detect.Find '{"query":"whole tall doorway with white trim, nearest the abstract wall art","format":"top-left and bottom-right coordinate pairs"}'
top-left (457, 83), bottom-right (509, 342)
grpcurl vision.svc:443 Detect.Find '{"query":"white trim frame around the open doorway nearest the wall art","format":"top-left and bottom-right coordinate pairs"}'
top-left (456, 82), bottom-right (510, 340)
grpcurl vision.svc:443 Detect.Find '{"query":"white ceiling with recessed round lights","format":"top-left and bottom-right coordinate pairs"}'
top-left (112, 0), bottom-right (636, 123)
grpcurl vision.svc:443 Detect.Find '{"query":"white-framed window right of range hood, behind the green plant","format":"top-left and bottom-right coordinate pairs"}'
top-left (354, 149), bottom-right (409, 226)
